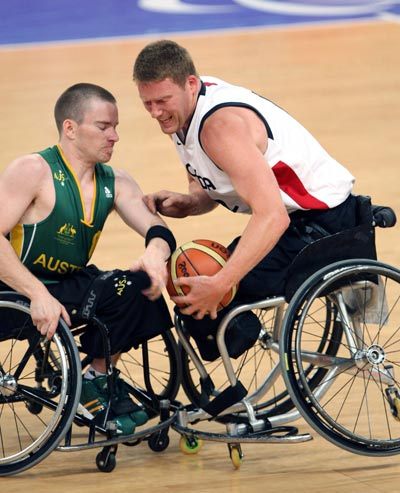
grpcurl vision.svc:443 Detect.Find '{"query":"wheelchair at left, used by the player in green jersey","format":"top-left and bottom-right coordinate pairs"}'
top-left (0, 291), bottom-right (181, 476)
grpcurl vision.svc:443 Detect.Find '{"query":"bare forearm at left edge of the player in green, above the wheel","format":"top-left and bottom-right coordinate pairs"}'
top-left (0, 234), bottom-right (46, 299)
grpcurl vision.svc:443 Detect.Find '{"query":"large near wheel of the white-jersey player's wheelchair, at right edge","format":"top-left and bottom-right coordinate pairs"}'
top-left (281, 260), bottom-right (400, 456)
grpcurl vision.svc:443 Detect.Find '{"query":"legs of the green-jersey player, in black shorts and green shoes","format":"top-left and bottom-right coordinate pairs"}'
top-left (51, 267), bottom-right (172, 434)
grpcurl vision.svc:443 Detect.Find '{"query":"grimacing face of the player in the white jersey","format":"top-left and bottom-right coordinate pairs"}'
top-left (138, 76), bottom-right (198, 134)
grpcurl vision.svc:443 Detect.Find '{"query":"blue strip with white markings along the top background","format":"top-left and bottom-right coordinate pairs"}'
top-left (0, 0), bottom-right (400, 45)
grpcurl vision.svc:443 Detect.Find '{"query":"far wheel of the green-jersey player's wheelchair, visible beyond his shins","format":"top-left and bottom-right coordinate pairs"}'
top-left (118, 330), bottom-right (181, 401)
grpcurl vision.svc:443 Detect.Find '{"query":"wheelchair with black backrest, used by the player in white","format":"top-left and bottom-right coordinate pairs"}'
top-left (172, 196), bottom-right (400, 468)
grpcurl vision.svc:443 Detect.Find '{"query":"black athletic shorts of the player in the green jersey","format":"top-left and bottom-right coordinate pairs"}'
top-left (1, 265), bottom-right (173, 358)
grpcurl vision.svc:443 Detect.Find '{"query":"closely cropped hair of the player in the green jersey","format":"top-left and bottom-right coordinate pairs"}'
top-left (54, 82), bottom-right (116, 134)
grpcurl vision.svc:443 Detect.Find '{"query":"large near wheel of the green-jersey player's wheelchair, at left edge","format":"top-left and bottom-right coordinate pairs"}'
top-left (0, 293), bottom-right (81, 476)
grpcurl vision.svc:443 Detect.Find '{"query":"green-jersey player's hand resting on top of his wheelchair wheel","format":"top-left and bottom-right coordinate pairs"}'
top-left (31, 290), bottom-right (71, 340)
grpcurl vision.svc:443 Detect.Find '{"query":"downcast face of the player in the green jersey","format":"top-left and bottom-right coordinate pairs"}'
top-left (75, 99), bottom-right (119, 163)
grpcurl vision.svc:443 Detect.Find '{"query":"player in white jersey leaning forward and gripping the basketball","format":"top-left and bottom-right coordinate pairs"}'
top-left (133, 40), bottom-right (356, 321)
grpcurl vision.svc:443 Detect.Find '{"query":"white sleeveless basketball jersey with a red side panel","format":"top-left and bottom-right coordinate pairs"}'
top-left (172, 76), bottom-right (354, 213)
